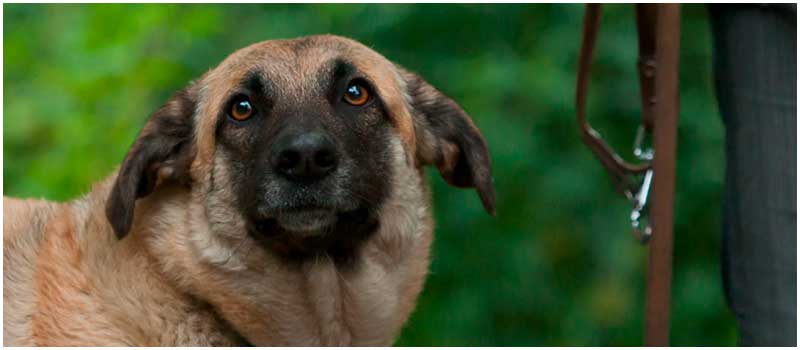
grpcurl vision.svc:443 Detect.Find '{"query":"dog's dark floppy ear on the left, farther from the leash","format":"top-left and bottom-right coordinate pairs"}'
top-left (106, 84), bottom-right (196, 239)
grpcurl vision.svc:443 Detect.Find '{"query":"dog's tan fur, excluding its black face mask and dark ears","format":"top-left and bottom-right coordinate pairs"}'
top-left (3, 36), bottom-right (433, 346)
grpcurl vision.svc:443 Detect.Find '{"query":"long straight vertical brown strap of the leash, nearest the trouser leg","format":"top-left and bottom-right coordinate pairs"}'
top-left (645, 4), bottom-right (680, 346)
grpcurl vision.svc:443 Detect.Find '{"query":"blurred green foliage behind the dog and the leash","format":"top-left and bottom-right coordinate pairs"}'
top-left (3, 4), bottom-right (736, 346)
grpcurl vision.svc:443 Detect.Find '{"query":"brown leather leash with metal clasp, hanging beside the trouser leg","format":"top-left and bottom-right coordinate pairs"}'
top-left (575, 4), bottom-right (680, 346)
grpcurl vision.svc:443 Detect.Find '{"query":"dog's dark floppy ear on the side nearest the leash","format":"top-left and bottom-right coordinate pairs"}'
top-left (401, 69), bottom-right (495, 215)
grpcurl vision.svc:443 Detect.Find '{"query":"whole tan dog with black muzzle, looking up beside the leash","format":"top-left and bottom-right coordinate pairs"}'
top-left (3, 35), bottom-right (495, 346)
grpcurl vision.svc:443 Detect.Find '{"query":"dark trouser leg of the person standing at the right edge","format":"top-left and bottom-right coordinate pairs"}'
top-left (709, 5), bottom-right (797, 346)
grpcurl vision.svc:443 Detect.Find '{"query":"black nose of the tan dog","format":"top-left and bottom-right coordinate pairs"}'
top-left (270, 132), bottom-right (339, 181)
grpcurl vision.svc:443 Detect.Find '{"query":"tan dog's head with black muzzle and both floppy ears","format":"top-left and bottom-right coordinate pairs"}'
top-left (107, 36), bottom-right (494, 260)
